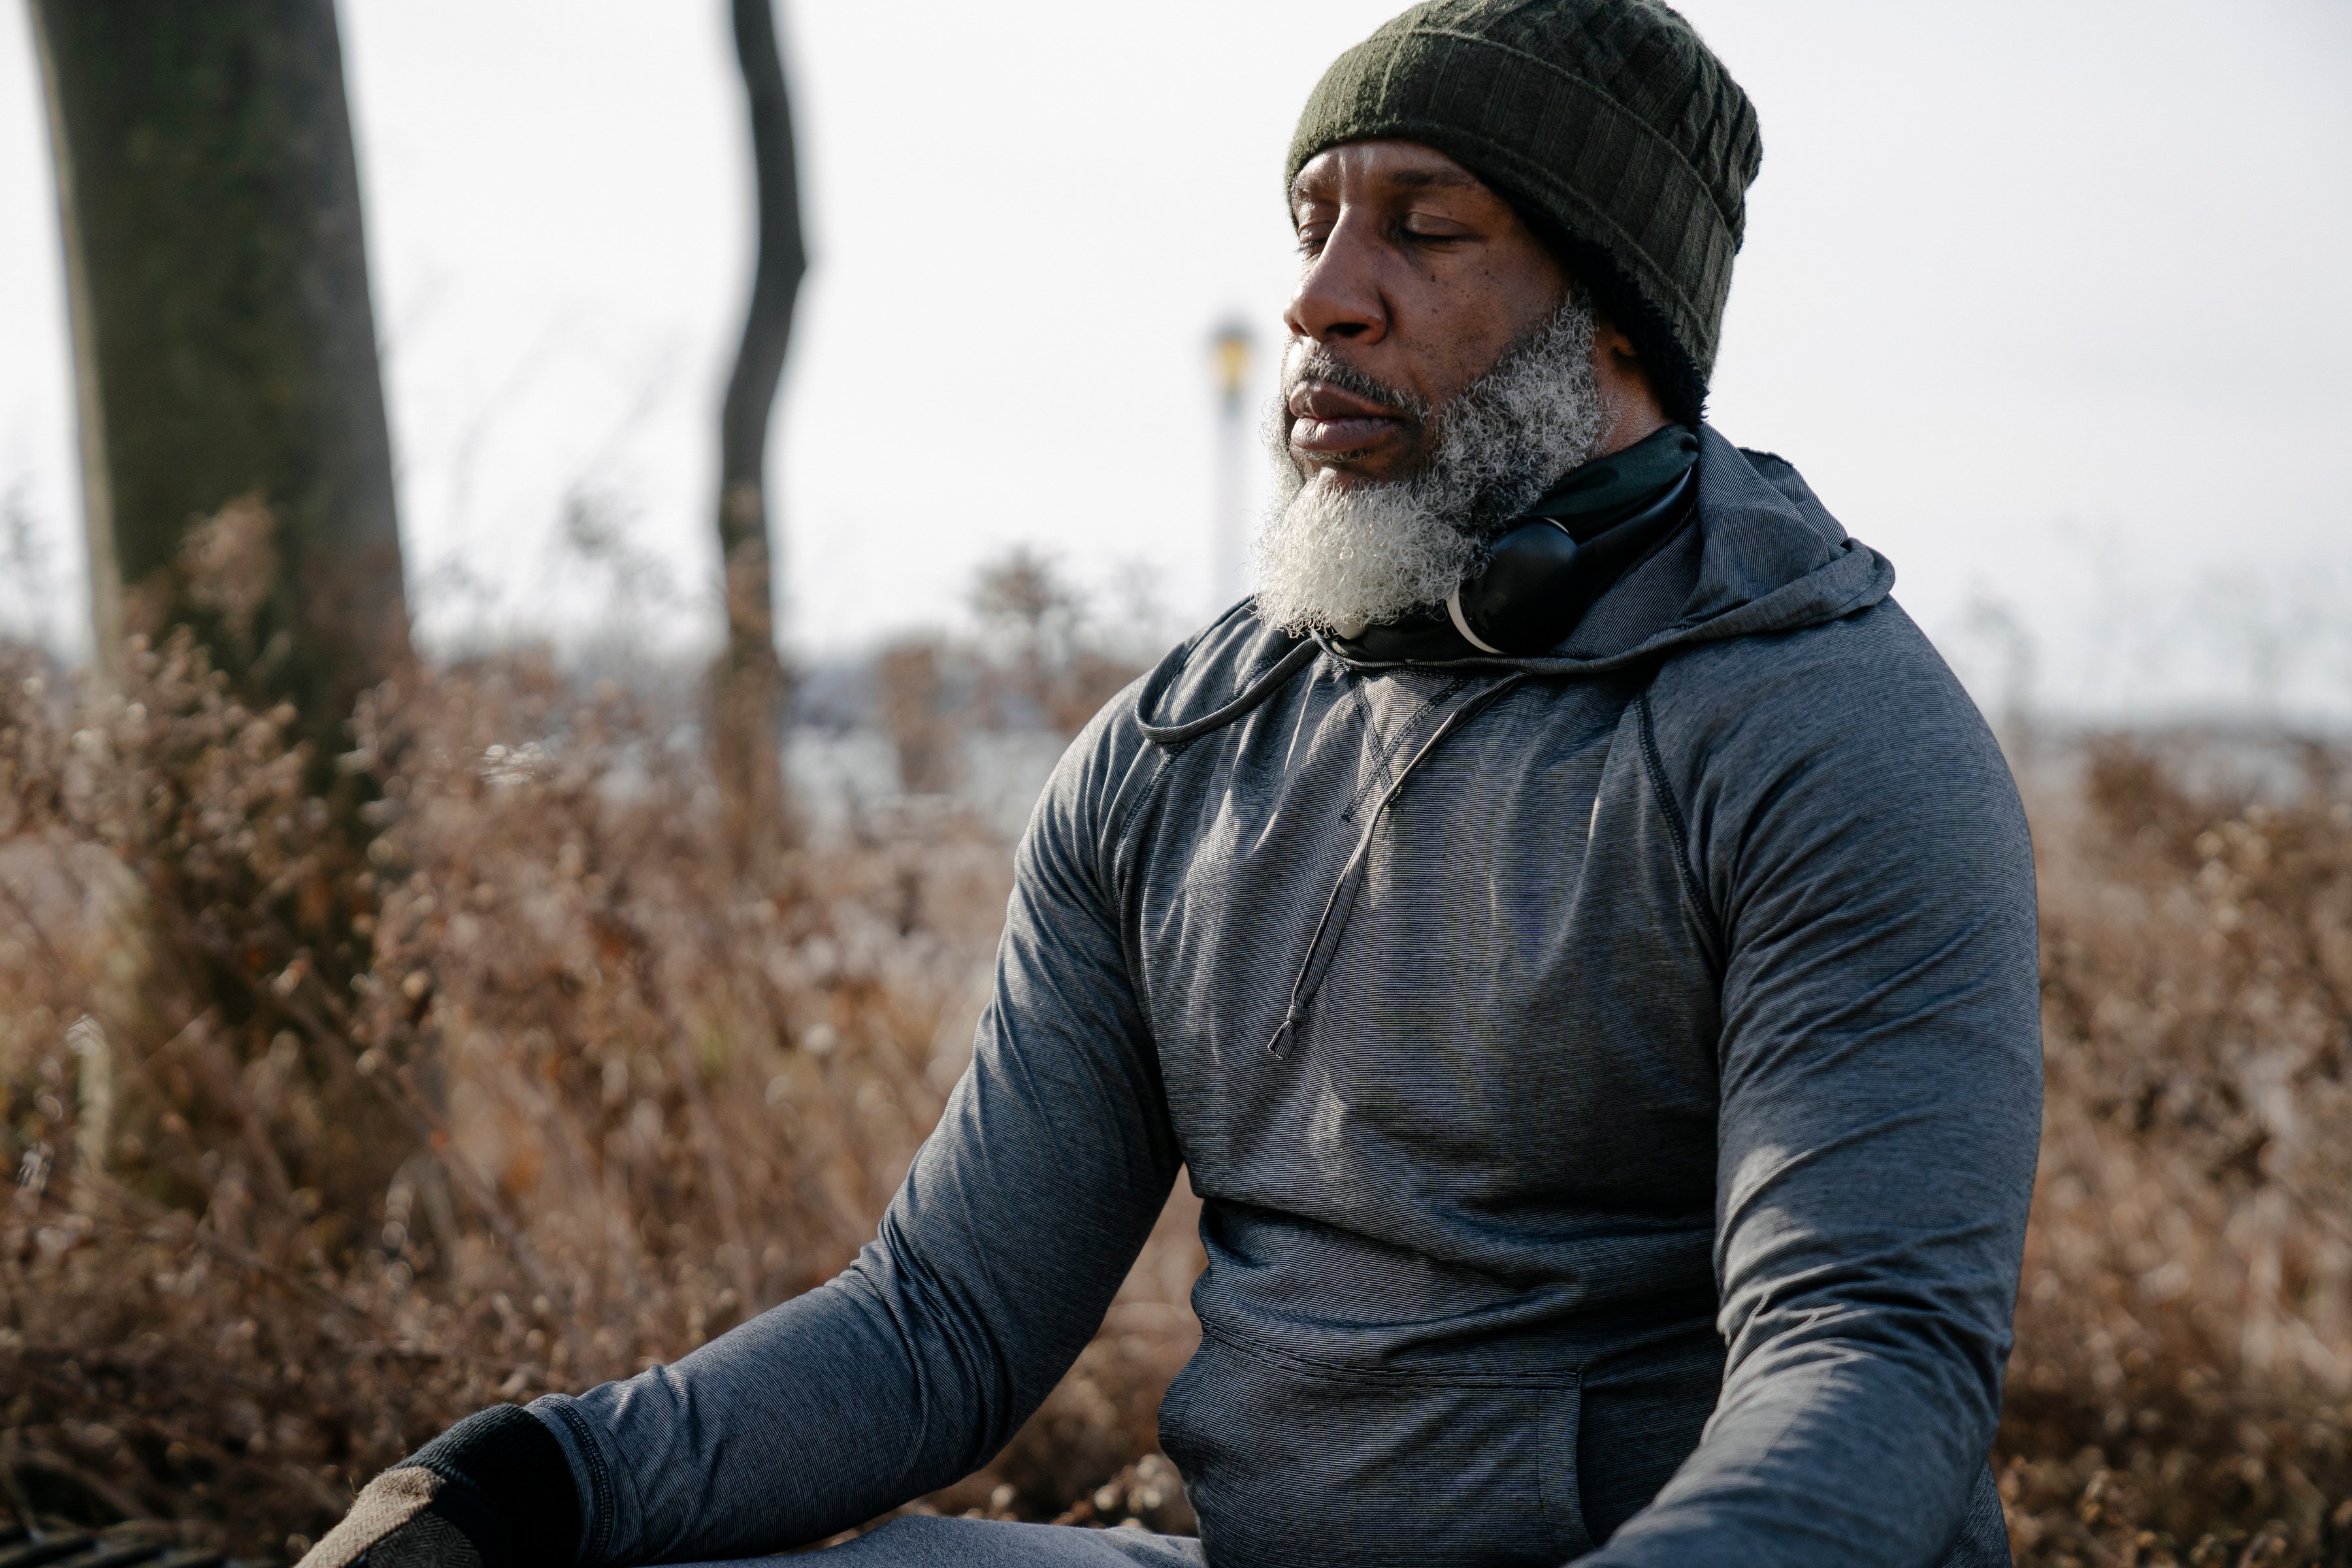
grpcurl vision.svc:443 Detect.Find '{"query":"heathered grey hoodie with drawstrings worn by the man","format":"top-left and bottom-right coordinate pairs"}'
top-left (534, 430), bottom-right (2042, 1568)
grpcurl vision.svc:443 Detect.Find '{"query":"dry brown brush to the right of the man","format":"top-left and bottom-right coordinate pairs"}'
top-left (2002, 740), bottom-right (2352, 1565)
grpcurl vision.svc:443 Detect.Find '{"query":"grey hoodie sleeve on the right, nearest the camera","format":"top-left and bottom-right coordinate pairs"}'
top-left (1583, 604), bottom-right (2042, 1568)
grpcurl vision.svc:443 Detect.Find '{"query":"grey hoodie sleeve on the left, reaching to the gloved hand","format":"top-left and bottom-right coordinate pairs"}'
top-left (532, 731), bottom-right (1179, 1568)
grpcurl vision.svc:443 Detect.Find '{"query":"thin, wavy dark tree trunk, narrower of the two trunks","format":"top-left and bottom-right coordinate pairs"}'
top-left (710, 0), bottom-right (809, 853)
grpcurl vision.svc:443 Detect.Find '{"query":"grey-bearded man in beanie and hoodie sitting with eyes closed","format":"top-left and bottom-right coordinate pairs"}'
top-left (313, 0), bottom-right (2042, 1568)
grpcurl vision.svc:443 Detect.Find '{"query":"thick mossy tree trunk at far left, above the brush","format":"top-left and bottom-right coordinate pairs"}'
top-left (31, 0), bottom-right (409, 745)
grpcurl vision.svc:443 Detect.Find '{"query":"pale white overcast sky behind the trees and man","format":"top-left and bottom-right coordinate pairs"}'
top-left (0, 0), bottom-right (2352, 712)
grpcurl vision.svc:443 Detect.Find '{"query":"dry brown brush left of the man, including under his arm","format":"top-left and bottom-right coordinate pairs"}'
top-left (0, 640), bottom-right (1197, 1554)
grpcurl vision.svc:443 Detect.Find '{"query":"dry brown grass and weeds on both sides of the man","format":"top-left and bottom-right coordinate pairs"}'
top-left (14, 620), bottom-right (2352, 1568)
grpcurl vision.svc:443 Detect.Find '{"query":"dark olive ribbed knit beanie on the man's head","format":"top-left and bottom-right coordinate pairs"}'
top-left (1282, 0), bottom-right (1764, 423)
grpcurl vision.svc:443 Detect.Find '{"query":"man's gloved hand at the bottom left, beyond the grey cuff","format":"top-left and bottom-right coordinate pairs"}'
top-left (297, 1406), bottom-right (579, 1568)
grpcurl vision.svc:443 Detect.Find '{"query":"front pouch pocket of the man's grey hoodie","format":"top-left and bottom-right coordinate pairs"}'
top-left (1160, 1331), bottom-right (1592, 1568)
